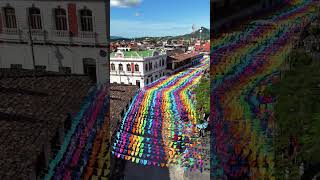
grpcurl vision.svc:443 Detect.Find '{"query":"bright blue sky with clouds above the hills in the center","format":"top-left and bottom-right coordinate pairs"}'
top-left (110, 0), bottom-right (210, 38)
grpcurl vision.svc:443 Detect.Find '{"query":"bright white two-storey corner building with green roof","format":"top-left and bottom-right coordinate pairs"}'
top-left (110, 50), bottom-right (167, 87)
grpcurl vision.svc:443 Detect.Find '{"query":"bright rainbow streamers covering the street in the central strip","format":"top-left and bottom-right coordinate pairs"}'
top-left (112, 57), bottom-right (209, 172)
